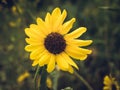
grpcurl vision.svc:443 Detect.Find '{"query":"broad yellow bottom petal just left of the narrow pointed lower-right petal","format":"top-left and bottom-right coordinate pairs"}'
top-left (56, 54), bottom-right (69, 71)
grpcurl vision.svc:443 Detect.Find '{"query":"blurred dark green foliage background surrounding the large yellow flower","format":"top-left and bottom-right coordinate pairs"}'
top-left (0, 0), bottom-right (120, 90)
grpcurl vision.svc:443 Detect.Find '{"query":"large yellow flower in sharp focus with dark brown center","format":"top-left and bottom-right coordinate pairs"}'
top-left (25, 8), bottom-right (92, 73)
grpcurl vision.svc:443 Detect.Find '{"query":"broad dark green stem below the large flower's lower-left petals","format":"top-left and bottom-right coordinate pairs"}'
top-left (39, 66), bottom-right (47, 90)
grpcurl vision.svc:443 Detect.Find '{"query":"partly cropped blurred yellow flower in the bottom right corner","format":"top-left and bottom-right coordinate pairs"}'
top-left (103, 75), bottom-right (120, 90)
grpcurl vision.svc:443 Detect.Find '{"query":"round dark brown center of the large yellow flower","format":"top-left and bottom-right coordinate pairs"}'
top-left (44, 32), bottom-right (66, 54)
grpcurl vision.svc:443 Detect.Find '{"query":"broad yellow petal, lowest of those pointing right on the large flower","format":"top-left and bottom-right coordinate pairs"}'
top-left (65, 46), bottom-right (87, 60)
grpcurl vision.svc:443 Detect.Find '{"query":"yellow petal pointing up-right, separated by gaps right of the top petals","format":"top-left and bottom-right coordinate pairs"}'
top-left (59, 18), bottom-right (75, 34)
